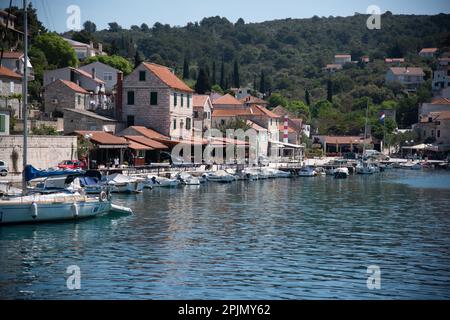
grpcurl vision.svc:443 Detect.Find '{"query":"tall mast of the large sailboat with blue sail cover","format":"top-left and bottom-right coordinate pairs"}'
top-left (22, 0), bottom-right (28, 194)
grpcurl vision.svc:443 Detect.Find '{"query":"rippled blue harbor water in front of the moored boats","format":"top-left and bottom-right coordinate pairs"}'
top-left (0, 170), bottom-right (450, 299)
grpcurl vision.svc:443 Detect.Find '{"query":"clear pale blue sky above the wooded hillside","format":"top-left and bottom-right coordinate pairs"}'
top-left (0, 0), bottom-right (450, 32)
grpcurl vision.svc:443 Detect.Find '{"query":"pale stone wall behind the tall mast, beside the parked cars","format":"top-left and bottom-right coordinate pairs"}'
top-left (0, 136), bottom-right (77, 173)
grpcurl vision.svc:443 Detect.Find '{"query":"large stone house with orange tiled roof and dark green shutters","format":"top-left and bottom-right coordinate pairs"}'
top-left (118, 62), bottom-right (194, 140)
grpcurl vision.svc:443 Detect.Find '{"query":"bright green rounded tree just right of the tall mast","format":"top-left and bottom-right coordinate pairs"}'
top-left (33, 33), bottom-right (78, 69)
